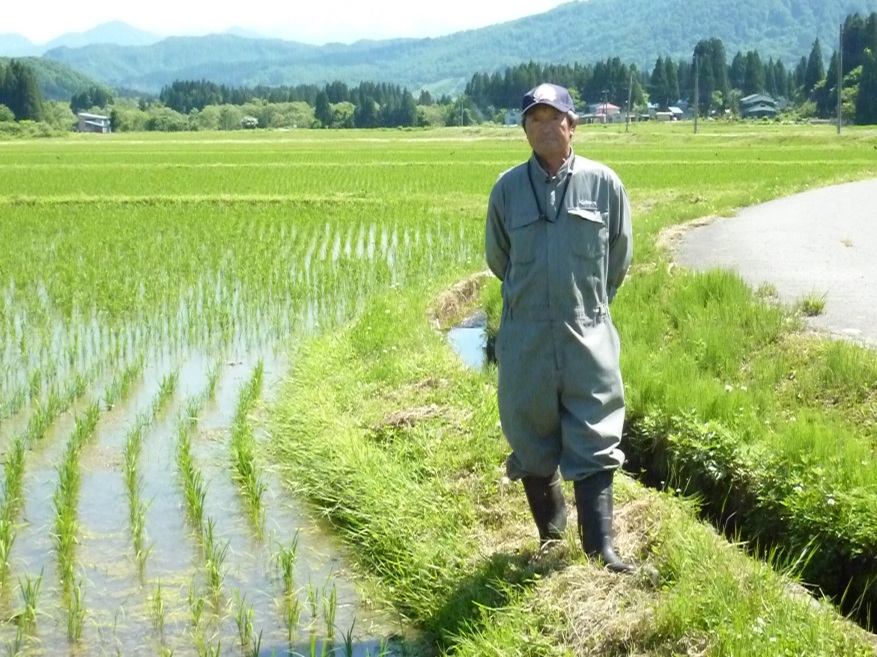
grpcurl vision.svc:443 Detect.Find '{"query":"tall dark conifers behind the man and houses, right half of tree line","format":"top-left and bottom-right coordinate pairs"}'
top-left (465, 13), bottom-right (877, 124)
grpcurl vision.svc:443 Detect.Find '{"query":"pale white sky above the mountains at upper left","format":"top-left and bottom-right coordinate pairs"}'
top-left (8, 0), bottom-right (563, 44)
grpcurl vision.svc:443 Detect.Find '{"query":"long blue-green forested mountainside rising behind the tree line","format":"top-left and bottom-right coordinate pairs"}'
top-left (45, 0), bottom-right (877, 92)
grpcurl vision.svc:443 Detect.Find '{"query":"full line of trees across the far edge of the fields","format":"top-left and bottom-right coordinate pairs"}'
top-left (0, 12), bottom-right (877, 131)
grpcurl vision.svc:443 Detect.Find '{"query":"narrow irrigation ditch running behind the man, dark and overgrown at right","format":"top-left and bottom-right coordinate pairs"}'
top-left (444, 277), bottom-right (877, 632)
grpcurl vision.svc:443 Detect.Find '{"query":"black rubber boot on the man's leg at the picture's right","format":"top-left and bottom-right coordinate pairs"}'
top-left (574, 470), bottom-right (636, 573)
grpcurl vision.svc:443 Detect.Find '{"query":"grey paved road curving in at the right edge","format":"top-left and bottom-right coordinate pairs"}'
top-left (676, 179), bottom-right (877, 345)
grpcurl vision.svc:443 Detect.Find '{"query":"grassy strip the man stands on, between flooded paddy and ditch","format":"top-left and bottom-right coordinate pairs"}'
top-left (273, 292), bottom-right (870, 657)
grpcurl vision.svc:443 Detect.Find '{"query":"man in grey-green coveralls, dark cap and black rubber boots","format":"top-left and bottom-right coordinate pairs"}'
top-left (485, 84), bottom-right (633, 572)
